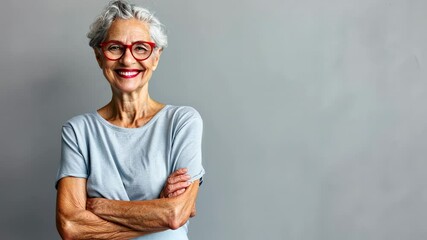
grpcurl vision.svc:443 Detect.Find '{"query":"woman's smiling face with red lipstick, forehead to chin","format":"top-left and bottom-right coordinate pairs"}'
top-left (95, 18), bottom-right (161, 93)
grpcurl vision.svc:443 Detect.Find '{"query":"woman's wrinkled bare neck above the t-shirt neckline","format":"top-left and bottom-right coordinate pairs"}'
top-left (98, 86), bottom-right (164, 128)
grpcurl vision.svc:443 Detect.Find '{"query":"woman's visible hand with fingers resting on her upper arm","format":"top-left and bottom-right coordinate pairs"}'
top-left (160, 168), bottom-right (191, 198)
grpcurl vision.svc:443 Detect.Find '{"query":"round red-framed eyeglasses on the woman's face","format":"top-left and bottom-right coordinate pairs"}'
top-left (100, 41), bottom-right (156, 61)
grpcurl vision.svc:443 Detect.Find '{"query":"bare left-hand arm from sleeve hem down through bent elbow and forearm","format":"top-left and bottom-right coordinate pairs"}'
top-left (56, 177), bottom-right (154, 239)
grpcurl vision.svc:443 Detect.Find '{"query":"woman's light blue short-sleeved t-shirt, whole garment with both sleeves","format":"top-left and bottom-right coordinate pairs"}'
top-left (57, 105), bottom-right (205, 240)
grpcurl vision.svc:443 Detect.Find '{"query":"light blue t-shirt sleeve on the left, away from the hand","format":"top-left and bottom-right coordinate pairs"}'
top-left (55, 124), bottom-right (88, 187)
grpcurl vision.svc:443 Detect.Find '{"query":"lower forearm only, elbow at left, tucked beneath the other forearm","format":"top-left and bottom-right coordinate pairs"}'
top-left (57, 207), bottom-right (146, 239)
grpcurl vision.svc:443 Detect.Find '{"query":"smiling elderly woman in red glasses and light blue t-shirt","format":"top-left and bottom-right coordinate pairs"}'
top-left (56, 1), bottom-right (204, 240)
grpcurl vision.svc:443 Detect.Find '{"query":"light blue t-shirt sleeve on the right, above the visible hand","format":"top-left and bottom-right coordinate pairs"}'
top-left (171, 112), bottom-right (205, 182)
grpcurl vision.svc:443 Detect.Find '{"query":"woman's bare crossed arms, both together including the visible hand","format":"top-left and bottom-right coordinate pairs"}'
top-left (56, 169), bottom-right (199, 239)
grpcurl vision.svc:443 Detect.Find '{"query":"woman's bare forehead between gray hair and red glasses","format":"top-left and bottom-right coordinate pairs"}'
top-left (104, 18), bottom-right (151, 44)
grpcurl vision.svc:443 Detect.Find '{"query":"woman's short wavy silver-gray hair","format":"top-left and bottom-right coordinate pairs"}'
top-left (87, 0), bottom-right (168, 49)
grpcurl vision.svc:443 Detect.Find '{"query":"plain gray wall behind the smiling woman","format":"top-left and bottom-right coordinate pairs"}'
top-left (0, 0), bottom-right (427, 240)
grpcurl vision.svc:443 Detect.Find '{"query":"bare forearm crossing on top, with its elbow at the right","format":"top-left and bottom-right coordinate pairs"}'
top-left (87, 180), bottom-right (199, 231)
